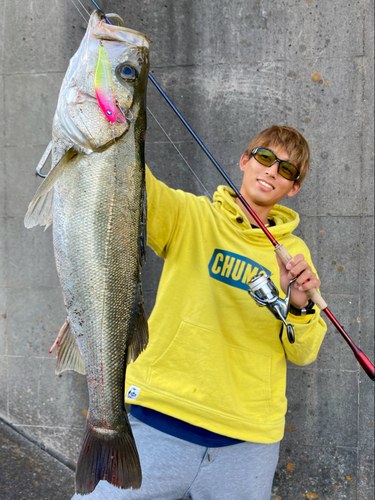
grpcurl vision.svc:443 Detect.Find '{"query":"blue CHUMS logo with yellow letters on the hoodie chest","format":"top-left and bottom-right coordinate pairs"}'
top-left (208, 248), bottom-right (271, 290)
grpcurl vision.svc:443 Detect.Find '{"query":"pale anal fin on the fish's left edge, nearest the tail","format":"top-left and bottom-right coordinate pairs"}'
top-left (50, 320), bottom-right (86, 375)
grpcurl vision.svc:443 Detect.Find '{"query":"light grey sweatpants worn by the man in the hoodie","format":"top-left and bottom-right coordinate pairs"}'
top-left (72, 416), bottom-right (280, 500)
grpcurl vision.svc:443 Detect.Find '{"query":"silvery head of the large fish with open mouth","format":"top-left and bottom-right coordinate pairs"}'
top-left (54, 10), bottom-right (149, 153)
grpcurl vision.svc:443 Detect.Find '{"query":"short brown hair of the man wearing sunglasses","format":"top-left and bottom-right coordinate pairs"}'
top-left (246, 125), bottom-right (310, 184)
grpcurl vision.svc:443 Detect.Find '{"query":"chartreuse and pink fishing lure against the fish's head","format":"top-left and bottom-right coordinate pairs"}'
top-left (95, 43), bottom-right (126, 123)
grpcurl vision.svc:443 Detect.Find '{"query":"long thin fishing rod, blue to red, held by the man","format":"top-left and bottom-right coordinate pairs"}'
top-left (91, 0), bottom-right (375, 381)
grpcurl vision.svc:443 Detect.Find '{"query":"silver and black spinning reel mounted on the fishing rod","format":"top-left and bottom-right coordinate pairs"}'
top-left (248, 273), bottom-right (298, 344)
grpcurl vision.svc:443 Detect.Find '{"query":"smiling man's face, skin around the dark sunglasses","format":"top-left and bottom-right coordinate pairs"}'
top-left (240, 146), bottom-right (301, 207)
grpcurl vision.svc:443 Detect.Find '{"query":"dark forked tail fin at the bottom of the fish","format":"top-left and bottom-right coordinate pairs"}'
top-left (75, 422), bottom-right (142, 495)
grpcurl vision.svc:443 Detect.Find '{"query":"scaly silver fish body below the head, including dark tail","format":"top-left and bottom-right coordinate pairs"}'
top-left (53, 141), bottom-right (145, 493)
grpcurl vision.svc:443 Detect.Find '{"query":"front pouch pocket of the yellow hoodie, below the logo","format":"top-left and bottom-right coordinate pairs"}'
top-left (148, 322), bottom-right (272, 421)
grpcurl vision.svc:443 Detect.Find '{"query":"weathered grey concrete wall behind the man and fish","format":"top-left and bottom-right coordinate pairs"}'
top-left (0, 0), bottom-right (374, 500)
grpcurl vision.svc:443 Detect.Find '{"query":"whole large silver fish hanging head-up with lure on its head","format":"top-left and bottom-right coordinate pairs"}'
top-left (25, 11), bottom-right (149, 494)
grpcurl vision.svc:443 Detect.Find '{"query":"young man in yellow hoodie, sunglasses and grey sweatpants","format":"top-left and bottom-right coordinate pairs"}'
top-left (75, 126), bottom-right (326, 500)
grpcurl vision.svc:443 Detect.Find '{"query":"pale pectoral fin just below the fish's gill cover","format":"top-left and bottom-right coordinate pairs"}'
top-left (24, 148), bottom-right (80, 229)
